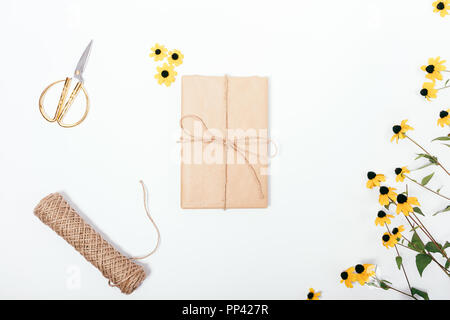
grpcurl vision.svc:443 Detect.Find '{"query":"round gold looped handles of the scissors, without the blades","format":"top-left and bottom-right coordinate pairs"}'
top-left (39, 78), bottom-right (89, 128)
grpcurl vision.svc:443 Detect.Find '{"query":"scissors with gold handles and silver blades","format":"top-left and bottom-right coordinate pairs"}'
top-left (39, 40), bottom-right (92, 128)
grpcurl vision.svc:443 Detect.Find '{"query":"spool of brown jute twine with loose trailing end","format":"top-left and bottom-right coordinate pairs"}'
top-left (34, 181), bottom-right (160, 294)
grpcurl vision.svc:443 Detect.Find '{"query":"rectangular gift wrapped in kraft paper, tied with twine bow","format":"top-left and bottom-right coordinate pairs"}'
top-left (180, 76), bottom-right (269, 209)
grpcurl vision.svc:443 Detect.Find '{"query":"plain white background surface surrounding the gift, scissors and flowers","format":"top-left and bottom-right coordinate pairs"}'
top-left (0, 0), bottom-right (450, 299)
